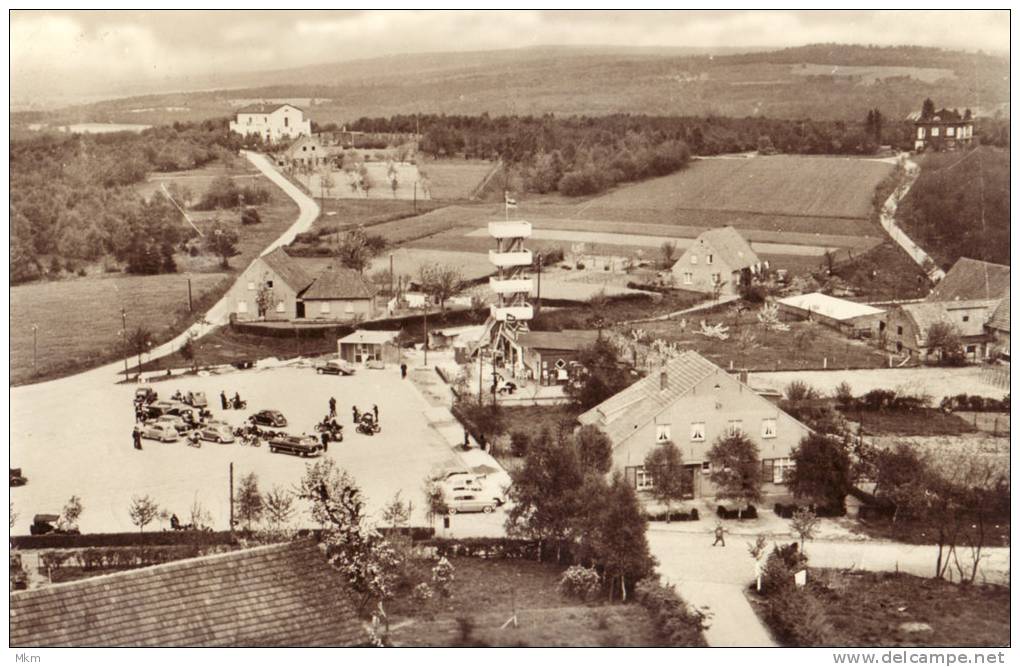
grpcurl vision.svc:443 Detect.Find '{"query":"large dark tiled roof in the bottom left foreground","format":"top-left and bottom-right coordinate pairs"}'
top-left (10, 541), bottom-right (367, 647)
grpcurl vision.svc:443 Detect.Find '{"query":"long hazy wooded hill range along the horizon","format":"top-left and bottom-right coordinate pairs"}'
top-left (12, 43), bottom-right (1009, 130)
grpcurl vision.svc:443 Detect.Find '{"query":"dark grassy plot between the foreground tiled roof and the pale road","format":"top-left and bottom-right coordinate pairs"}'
top-left (387, 558), bottom-right (661, 647)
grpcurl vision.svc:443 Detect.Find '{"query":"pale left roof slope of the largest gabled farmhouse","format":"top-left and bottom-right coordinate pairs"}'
top-left (577, 350), bottom-right (722, 446)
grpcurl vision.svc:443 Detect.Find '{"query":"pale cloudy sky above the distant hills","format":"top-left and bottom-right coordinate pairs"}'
top-left (10, 10), bottom-right (1010, 104)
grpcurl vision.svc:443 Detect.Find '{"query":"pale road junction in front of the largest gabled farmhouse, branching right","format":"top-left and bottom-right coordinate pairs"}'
top-left (648, 528), bottom-right (1010, 647)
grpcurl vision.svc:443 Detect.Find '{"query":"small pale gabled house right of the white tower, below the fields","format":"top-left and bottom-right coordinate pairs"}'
top-left (672, 226), bottom-right (764, 295)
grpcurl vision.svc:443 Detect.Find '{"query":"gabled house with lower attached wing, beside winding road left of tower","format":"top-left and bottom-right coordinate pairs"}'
top-left (230, 248), bottom-right (377, 321)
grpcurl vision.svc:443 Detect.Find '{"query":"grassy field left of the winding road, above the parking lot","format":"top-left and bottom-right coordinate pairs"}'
top-left (10, 162), bottom-right (298, 384)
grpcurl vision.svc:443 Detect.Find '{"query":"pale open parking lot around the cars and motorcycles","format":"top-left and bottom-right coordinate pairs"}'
top-left (11, 367), bottom-right (495, 534)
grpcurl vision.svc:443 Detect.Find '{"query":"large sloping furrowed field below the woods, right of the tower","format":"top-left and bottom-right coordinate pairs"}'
top-left (588, 155), bottom-right (893, 218)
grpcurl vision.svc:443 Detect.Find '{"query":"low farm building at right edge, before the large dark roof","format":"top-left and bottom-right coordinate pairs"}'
top-left (879, 299), bottom-right (1000, 361)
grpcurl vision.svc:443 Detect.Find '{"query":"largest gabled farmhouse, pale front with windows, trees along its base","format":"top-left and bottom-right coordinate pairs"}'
top-left (578, 350), bottom-right (809, 498)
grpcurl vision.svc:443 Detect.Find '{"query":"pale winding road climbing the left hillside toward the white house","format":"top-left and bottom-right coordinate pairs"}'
top-left (11, 151), bottom-right (319, 397)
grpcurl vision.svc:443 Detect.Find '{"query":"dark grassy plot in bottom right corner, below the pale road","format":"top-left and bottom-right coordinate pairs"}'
top-left (762, 571), bottom-right (1010, 647)
